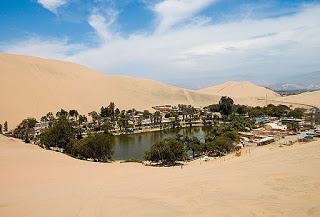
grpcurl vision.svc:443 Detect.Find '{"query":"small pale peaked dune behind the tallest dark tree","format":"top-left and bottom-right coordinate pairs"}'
top-left (198, 81), bottom-right (279, 98)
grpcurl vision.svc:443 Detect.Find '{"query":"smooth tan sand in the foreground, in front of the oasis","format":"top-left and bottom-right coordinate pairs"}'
top-left (0, 136), bottom-right (320, 217)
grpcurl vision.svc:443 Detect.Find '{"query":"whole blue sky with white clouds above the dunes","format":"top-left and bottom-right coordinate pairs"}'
top-left (0, 0), bottom-right (320, 88)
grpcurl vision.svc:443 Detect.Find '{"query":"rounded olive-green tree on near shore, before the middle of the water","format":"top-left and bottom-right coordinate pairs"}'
top-left (145, 138), bottom-right (187, 166)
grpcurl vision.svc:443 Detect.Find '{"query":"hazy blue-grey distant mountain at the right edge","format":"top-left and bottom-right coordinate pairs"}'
top-left (269, 71), bottom-right (320, 91)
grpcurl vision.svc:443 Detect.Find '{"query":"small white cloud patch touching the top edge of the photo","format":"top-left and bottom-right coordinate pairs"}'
top-left (152, 0), bottom-right (217, 33)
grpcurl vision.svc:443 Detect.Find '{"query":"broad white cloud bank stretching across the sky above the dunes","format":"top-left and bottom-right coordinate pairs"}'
top-left (2, 2), bottom-right (320, 87)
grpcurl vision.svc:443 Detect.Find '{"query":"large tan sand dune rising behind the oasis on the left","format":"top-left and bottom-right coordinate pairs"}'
top-left (0, 54), bottom-right (218, 128)
